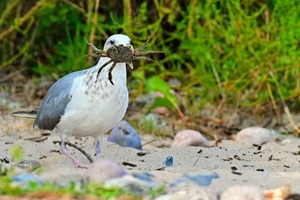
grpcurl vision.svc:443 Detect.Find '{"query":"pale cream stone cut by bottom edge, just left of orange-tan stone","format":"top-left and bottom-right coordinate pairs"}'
top-left (220, 185), bottom-right (265, 200)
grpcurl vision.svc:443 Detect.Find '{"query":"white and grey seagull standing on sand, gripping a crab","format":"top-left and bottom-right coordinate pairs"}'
top-left (12, 34), bottom-right (133, 168)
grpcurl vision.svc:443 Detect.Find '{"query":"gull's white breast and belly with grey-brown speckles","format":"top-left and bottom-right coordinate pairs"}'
top-left (55, 63), bottom-right (128, 140)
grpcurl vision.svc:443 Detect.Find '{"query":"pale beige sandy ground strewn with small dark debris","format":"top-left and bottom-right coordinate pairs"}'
top-left (0, 111), bottom-right (300, 197)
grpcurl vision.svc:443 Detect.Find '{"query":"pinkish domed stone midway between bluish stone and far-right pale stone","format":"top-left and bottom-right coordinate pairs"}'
top-left (171, 130), bottom-right (209, 148)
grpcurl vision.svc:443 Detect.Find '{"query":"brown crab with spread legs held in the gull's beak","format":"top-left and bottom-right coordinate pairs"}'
top-left (86, 37), bottom-right (164, 85)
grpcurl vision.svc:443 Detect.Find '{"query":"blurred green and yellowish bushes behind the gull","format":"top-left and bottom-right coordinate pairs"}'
top-left (0, 0), bottom-right (300, 115)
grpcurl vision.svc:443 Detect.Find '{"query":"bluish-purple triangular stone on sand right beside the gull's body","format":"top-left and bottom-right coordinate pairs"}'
top-left (107, 120), bottom-right (142, 150)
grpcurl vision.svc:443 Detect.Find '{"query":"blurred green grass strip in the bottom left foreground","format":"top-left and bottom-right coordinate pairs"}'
top-left (0, 146), bottom-right (145, 200)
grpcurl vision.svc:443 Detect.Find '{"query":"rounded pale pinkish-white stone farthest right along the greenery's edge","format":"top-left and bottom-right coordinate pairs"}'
top-left (236, 127), bottom-right (274, 146)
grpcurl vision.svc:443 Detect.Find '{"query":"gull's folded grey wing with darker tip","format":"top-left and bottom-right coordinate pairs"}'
top-left (33, 70), bottom-right (86, 130)
